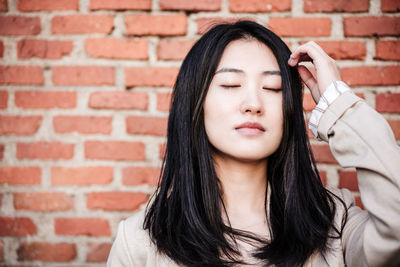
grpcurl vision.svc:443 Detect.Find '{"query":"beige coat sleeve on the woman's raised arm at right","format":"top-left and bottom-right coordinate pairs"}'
top-left (316, 82), bottom-right (400, 266)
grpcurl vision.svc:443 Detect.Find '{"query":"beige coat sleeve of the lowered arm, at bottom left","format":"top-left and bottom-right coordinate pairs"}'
top-left (107, 221), bottom-right (135, 267)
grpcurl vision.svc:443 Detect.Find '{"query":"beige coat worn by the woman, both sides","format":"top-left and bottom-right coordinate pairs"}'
top-left (107, 92), bottom-right (400, 267)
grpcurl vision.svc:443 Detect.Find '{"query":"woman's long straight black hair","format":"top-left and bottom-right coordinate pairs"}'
top-left (143, 21), bottom-right (341, 266)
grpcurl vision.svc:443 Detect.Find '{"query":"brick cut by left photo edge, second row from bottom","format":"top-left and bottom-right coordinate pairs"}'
top-left (0, 217), bottom-right (37, 236)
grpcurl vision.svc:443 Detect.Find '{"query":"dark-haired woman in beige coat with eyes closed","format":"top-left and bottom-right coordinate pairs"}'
top-left (108, 21), bottom-right (400, 267)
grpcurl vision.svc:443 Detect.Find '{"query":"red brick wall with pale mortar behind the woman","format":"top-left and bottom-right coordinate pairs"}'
top-left (0, 0), bottom-right (400, 266)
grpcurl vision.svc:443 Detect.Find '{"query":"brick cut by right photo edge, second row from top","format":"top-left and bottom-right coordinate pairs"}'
top-left (343, 17), bottom-right (400, 37)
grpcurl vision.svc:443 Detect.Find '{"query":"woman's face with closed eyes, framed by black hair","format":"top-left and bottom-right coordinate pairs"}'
top-left (204, 40), bottom-right (283, 161)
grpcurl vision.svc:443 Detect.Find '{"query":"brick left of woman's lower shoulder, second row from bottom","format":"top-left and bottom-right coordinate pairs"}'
top-left (54, 218), bottom-right (111, 236)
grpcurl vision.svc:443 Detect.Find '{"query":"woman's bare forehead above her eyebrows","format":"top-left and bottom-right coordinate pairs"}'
top-left (218, 39), bottom-right (279, 72)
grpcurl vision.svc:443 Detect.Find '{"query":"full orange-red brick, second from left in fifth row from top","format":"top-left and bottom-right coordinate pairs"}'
top-left (15, 91), bottom-right (76, 109)
